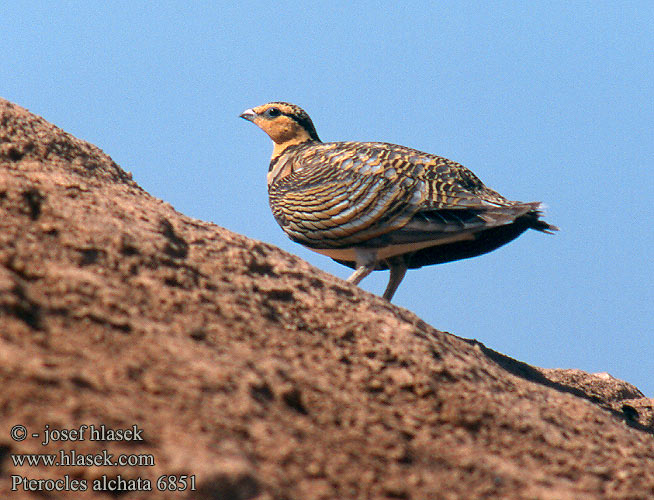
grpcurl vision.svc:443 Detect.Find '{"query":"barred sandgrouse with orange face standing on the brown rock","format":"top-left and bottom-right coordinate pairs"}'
top-left (240, 101), bottom-right (558, 302)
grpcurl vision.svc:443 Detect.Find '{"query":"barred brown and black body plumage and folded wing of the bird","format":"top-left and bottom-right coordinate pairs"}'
top-left (269, 142), bottom-right (552, 265)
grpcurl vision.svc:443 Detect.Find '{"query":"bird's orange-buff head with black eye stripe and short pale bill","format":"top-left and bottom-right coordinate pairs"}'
top-left (240, 102), bottom-right (320, 156)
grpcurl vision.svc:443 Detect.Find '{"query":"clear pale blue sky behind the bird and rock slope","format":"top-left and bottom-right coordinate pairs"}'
top-left (0, 1), bottom-right (654, 397)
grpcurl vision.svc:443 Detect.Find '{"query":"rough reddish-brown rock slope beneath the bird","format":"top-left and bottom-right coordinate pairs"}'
top-left (0, 100), bottom-right (654, 500)
